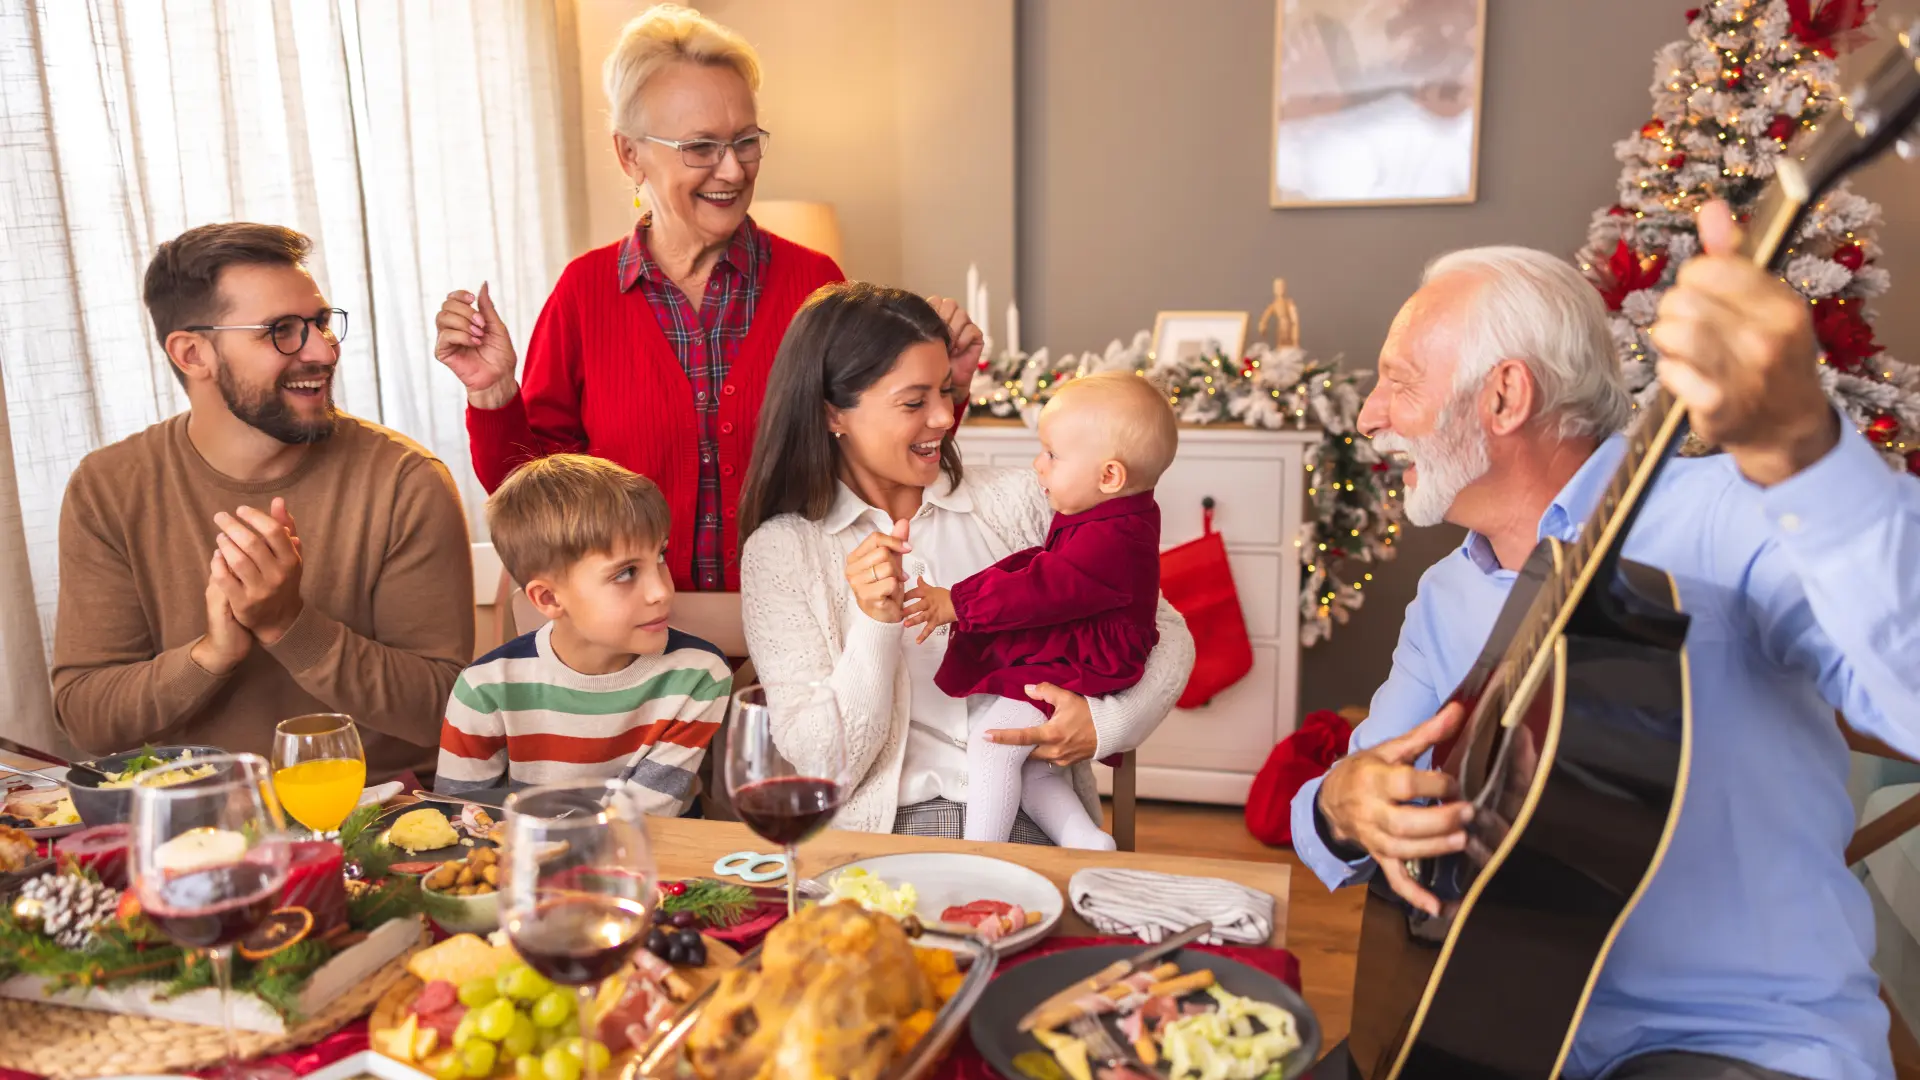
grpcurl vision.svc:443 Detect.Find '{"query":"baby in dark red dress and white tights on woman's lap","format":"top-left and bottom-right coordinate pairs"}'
top-left (906, 371), bottom-right (1179, 849)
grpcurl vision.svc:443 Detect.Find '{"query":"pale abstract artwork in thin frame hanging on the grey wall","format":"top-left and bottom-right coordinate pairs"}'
top-left (1269, 0), bottom-right (1486, 208)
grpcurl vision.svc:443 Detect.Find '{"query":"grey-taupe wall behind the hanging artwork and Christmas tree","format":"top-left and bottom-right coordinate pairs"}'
top-left (1018, 0), bottom-right (1920, 709)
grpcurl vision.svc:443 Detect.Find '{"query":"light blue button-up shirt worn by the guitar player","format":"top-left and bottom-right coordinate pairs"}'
top-left (1292, 419), bottom-right (1920, 1080)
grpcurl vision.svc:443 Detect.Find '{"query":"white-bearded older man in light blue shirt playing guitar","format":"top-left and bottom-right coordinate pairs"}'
top-left (1292, 204), bottom-right (1920, 1080)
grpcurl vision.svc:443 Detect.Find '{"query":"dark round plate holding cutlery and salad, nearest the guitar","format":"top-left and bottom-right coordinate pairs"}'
top-left (970, 945), bottom-right (1321, 1080)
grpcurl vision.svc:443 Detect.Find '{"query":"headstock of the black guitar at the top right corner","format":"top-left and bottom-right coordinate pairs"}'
top-left (1743, 23), bottom-right (1920, 269)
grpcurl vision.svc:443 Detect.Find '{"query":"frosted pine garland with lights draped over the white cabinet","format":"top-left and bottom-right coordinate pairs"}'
top-left (970, 331), bottom-right (1404, 646)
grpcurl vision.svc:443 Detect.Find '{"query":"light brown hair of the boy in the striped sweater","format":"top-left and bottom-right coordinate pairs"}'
top-left (486, 454), bottom-right (672, 584)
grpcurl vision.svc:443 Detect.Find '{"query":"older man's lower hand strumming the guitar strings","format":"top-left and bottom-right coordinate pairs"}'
top-left (1319, 703), bottom-right (1473, 915)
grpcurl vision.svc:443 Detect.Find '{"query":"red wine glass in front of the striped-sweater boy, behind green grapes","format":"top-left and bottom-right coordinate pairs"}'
top-left (499, 780), bottom-right (659, 1080)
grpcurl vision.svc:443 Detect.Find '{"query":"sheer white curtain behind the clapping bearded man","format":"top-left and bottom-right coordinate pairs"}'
top-left (0, 0), bottom-right (574, 742)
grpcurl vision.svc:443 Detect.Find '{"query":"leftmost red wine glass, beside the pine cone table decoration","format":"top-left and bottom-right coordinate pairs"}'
top-left (132, 753), bottom-right (292, 1080)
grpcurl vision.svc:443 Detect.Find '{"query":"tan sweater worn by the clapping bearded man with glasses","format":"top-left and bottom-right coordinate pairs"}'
top-left (54, 413), bottom-right (474, 780)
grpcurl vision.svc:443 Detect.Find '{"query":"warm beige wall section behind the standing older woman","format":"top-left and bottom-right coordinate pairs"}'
top-left (574, 0), bottom-right (1014, 300)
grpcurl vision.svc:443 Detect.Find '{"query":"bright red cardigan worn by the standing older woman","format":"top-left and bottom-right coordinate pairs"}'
top-left (467, 234), bottom-right (845, 590)
